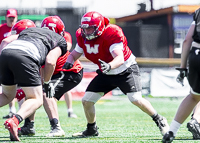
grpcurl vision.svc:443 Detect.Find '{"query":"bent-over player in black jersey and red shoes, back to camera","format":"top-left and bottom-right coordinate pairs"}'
top-left (0, 17), bottom-right (67, 141)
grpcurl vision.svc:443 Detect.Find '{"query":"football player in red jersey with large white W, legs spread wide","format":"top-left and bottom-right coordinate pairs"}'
top-left (63, 11), bottom-right (169, 137)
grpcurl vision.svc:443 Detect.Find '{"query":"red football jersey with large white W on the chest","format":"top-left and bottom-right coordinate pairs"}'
top-left (76, 24), bottom-right (132, 68)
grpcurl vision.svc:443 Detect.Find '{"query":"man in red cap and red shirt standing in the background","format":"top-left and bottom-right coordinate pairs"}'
top-left (0, 8), bottom-right (18, 119)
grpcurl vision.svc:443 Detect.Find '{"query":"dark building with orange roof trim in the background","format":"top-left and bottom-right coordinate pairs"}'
top-left (116, 5), bottom-right (200, 58)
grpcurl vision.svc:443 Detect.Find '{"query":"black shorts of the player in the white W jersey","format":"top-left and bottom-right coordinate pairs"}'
top-left (86, 64), bottom-right (142, 94)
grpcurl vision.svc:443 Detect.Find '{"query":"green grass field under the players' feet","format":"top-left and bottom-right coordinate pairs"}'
top-left (0, 96), bottom-right (198, 143)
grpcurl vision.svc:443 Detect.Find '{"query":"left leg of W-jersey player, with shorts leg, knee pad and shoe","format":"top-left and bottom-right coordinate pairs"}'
top-left (72, 72), bottom-right (112, 137)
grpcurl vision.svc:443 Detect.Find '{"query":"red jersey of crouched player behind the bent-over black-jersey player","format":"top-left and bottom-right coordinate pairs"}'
top-left (53, 32), bottom-right (83, 75)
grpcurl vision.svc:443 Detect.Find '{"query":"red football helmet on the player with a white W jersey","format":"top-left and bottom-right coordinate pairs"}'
top-left (81, 11), bottom-right (109, 40)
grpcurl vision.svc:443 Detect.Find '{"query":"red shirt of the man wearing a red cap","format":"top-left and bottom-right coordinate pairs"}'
top-left (0, 23), bottom-right (12, 43)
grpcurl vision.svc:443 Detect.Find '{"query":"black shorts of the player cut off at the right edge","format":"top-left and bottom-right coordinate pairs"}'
top-left (188, 47), bottom-right (200, 93)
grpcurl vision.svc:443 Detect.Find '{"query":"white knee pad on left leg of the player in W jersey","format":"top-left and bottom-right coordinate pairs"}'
top-left (82, 91), bottom-right (104, 103)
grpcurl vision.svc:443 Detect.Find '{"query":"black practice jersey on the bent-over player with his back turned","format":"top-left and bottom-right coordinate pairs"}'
top-left (17, 27), bottom-right (67, 65)
